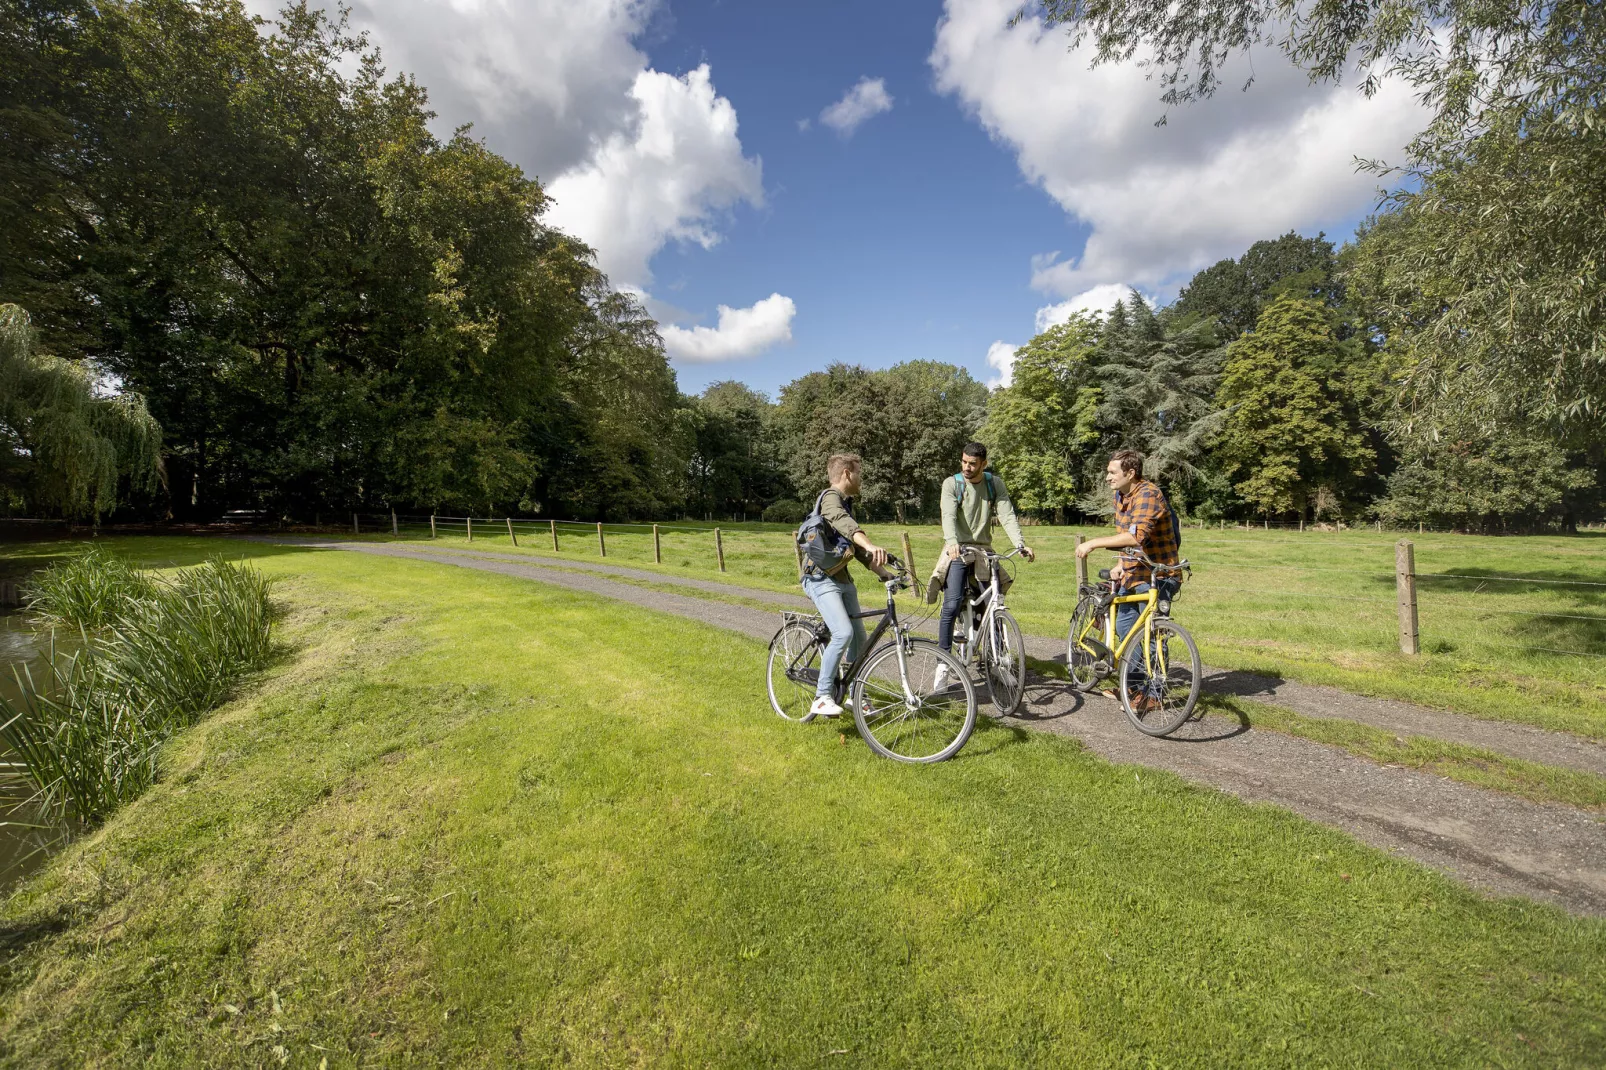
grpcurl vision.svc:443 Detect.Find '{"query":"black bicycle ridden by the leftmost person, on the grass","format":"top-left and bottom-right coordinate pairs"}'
top-left (769, 556), bottom-right (976, 762)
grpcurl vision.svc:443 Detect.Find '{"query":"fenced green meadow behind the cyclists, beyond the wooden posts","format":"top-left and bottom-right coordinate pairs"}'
top-left (364, 525), bottom-right (1606, 739)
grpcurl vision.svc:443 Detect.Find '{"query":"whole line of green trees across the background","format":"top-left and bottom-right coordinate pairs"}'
top-left (0, 0), bottom-right (1606, 530)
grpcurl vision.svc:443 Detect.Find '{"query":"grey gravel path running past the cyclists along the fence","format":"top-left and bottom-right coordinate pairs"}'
top-left (250, 538), bottom-right (1606, 916)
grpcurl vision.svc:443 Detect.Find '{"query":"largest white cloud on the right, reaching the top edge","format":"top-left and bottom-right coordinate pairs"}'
top-left (930, 0), bottom-right (1425, 297)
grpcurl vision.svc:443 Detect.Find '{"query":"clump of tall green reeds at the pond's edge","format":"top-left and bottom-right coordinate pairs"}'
top-left (0, 551), bottom-right (271, 823)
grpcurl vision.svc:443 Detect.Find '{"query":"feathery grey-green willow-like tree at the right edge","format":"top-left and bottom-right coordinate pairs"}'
top-left (1349, 112), bottom-right (1606, 442)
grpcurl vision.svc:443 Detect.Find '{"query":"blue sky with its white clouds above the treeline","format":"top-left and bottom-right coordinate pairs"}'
top-left (249, 0), bottom-right (1423, 394)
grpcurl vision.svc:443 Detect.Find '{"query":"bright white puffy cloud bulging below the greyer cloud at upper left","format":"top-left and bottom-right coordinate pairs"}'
top-left (548, 64), bottom-right (764, 288)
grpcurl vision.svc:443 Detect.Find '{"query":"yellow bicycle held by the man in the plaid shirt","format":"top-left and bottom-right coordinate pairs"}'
top-left (1065, 549), bottom-right (1203, 736)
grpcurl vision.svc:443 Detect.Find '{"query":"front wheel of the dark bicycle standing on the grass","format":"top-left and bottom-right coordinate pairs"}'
top-left (853, 639), bottom-right (976, 762)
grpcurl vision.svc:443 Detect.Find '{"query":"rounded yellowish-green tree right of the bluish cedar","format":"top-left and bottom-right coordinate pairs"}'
top-left (1216, 297), bottom-right (1376, 517)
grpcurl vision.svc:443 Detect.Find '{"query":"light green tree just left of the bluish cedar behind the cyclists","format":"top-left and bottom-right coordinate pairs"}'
top-left (981, 315), bottom-right (1100, 516)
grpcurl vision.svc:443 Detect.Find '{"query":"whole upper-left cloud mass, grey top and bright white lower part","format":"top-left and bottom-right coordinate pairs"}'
top-left (246, 0), bottom-right (790, 356)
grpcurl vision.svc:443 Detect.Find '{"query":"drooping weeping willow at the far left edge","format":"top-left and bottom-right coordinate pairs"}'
top-left (0, 305), bottom-right (162, 519)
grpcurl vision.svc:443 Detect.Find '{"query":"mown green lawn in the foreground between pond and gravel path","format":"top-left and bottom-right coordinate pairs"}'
top-left (0, 540), bottom-right (1606, 1067)
